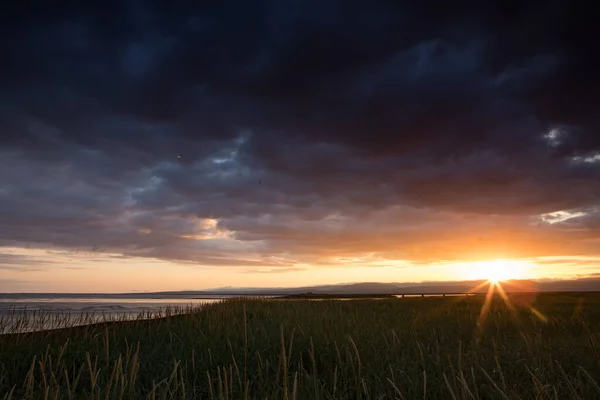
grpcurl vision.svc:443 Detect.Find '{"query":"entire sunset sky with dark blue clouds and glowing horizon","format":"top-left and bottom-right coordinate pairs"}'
top-left (0, 0), bottom-right (600, 292)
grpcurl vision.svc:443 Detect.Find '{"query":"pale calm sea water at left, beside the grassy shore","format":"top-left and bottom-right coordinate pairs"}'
top-left (0, 294), bottom-right (244, 335)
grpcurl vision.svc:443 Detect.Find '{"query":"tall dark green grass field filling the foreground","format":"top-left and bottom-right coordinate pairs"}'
top-left (0, 294), bottom-right (600, 400)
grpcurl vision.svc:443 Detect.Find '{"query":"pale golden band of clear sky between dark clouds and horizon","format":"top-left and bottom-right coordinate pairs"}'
top-left (0, 247), bottom-right (600, 293)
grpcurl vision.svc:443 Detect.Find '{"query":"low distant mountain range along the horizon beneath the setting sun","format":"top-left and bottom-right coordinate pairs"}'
top-left (0, 276), bottom-right (600, 298)
